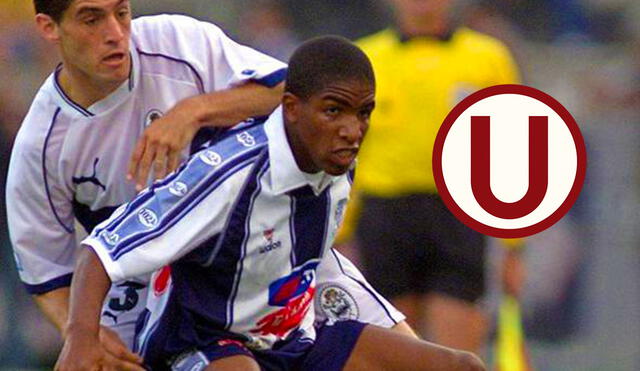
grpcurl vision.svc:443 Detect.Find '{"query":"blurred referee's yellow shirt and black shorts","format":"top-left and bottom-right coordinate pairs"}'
top-left (346, 28), bottom-right (518, 301)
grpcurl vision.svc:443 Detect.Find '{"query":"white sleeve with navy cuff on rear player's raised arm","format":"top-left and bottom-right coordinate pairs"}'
top-left (135, 15), bottom-right (286, 92)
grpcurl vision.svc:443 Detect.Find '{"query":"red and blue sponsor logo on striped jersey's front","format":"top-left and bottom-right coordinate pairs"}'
top-left (250, 262), bottom-right (318, 337)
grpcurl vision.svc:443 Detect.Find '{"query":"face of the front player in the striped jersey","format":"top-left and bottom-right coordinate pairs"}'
top-left (285, 80), bottom-right (375, 175)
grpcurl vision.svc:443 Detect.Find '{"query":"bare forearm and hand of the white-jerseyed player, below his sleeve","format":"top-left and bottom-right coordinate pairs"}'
top-left (128, 82), bottom-right (284, 191)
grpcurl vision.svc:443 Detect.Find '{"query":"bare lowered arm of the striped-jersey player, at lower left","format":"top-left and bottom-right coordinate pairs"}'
top-left (55, 249), bottom-right (144, 371)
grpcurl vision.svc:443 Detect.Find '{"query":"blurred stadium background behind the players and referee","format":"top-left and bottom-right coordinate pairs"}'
top-left (0, 0), bottom-right (640, 371)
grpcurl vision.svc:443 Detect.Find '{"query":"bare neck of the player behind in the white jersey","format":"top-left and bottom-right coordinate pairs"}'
top-left (58, 66), bottom-right (122, 108)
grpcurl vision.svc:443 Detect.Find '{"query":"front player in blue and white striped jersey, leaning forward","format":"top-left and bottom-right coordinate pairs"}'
top-left (56, 37), bottom-right (482, 371)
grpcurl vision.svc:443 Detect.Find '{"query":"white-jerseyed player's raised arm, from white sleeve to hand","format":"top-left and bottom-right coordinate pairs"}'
top-left (129, 16), bottom-right (286, 186)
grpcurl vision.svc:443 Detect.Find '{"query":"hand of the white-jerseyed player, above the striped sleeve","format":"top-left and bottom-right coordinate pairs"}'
top-left (127, 99), bottom-right (200, 191)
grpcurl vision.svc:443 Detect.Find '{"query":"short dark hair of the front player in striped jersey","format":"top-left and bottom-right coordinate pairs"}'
top-left (285, 36), bottom-right (375, 100)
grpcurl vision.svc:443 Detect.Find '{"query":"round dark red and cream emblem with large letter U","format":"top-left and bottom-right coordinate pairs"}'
top-left (433, 85), bottom-right (586, 238)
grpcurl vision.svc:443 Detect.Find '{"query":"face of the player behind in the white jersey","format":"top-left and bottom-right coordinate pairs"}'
top-left (58, 0), bottom-right (131, 83)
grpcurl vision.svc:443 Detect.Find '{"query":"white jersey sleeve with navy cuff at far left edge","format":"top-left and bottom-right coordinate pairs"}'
top-left (6, 110), bottom-right (77, 294)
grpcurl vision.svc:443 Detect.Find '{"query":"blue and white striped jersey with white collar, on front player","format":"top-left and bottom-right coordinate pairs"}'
top-left (83, 109), bottom-right (351, 355)
